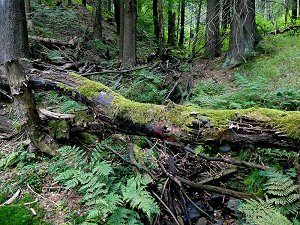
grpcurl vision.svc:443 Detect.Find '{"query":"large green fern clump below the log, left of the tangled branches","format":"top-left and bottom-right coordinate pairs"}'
top-left (56, 141), bottom-right (159, 224)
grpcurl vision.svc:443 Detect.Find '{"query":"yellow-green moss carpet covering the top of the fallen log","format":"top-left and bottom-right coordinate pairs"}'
top-left (71, 73), bottom-right (300, 139)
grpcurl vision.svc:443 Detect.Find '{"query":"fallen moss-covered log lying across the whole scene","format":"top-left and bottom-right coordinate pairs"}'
top-left (30, 73), bottom-right (300, 150)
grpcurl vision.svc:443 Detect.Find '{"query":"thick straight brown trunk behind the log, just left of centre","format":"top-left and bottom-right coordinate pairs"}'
top-left (122, 0), bottom-right (137, 67)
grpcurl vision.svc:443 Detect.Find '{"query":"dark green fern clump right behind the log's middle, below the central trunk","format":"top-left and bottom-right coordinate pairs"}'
top-left (120, 69), bottom-right (167, 104)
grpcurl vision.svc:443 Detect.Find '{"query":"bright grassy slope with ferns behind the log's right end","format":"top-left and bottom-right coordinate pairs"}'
top-left (191, 36), bottom-right (300, 110)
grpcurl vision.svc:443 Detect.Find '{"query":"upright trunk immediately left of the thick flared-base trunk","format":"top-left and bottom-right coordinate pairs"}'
top-left (203, 0), bottom-right (221, 59)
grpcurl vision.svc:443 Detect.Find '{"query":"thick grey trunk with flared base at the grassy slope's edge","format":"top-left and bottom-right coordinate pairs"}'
top-left (224, 0), bottom-right (259, 66)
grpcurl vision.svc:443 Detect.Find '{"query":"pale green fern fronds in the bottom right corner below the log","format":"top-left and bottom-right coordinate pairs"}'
top-left (239, 171), bottom-right (300, 225)
